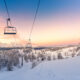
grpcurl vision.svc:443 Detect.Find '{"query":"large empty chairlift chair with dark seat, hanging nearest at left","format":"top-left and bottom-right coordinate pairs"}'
top-left (4, 18), bottom-right (17, 35)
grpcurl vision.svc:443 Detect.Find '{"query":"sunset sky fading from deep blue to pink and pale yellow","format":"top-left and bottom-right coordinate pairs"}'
top-left (0, 0), bottom-right (80, 46)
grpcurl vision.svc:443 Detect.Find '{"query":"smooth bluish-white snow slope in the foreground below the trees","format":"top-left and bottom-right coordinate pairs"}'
top-left (0, 56), bottom-right (80, 80)
